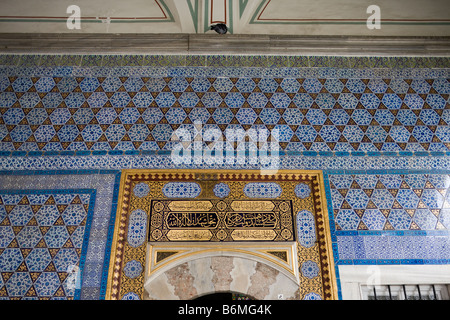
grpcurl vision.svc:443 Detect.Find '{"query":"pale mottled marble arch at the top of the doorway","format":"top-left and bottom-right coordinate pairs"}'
top-left (144, 245), bottom-right (299, 300)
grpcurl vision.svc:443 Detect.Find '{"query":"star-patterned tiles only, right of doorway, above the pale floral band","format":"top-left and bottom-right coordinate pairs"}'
top-left (329, 173), bottom-right (450, 231)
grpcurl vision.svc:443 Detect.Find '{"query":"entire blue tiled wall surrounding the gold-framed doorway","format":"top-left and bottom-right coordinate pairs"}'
top-left (0, 55), bottom-right (450, 299)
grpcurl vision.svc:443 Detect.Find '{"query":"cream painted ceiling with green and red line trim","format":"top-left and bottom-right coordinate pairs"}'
top-left (0, 0), bottom-right (450, 36)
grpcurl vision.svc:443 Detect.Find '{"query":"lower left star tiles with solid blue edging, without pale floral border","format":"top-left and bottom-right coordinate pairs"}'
top-left (0, 189), bottom-right (95, 299)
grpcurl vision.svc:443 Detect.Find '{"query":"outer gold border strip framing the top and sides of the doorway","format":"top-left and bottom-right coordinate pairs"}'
top-left (105, 169), bottom-right (338, 300)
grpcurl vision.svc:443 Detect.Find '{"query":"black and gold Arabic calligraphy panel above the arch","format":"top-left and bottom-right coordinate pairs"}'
top-left (148, 199), bottom-right (295, 242)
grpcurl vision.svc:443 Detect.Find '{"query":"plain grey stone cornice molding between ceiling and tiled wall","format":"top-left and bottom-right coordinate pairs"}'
top-left (0, 33), bottom-right (450, 57)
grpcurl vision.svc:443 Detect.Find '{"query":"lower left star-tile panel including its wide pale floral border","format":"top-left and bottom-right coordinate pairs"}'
top-left (0, 171), bottom-right (120, 300)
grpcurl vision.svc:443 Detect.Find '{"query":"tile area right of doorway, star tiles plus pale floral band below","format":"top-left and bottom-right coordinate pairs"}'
top-left (325, 170), bottom-right (450, 264)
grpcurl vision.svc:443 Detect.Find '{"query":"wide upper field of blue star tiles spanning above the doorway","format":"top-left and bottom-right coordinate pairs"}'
top-left (0, 68), bottom-right (450, 152)
